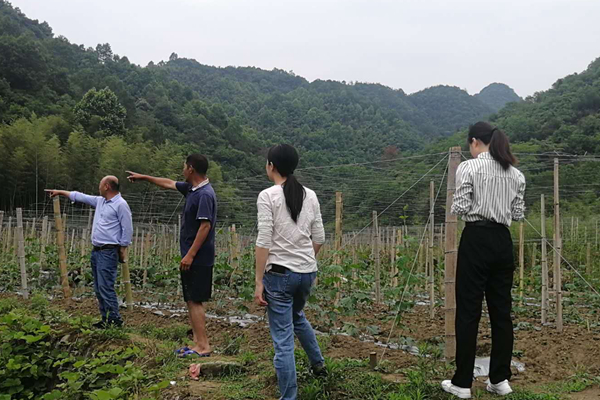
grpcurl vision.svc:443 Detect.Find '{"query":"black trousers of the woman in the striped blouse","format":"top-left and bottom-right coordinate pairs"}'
top-left (452, 224), bottom-right (515, 388)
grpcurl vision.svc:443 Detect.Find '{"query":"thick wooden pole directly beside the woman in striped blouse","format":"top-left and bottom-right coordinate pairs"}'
top-left (444, 147), bottom-right (461, 361)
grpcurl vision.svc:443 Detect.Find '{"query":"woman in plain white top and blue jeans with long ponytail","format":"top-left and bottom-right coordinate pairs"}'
top-left (254, 144), bottom-right (326, 400)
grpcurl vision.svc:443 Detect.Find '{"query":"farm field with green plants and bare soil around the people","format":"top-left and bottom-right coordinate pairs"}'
top-left (0, 209), bottom-right (600, 400)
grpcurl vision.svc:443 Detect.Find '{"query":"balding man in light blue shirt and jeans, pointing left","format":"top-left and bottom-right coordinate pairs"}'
top-left (46, 176), bottom-right (133, 328)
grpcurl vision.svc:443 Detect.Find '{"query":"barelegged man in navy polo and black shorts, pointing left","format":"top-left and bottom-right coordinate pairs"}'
top-left (127, 154), bottom-right (217, 357)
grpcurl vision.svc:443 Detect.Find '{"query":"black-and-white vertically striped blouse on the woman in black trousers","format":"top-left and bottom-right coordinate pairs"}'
top-left (451, 152), bottom-right (525, 226)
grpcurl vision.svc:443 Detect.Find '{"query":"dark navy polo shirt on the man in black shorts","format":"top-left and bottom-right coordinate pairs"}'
top-left (175, 182), bottom-right (217, 267)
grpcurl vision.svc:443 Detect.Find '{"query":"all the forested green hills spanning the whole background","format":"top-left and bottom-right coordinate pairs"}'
top-left (0, 0), bottom-right (600, 225)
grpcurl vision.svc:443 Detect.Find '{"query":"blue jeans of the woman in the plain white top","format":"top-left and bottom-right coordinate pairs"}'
top-left (263, 270), bottom-right (325, 400)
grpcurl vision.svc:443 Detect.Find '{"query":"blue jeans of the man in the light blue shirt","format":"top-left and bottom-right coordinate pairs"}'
top-left (92, 248), bottom-right (121, 322)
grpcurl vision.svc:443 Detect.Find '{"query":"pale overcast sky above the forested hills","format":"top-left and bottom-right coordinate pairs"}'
top-left (12, 0), bottom-right (600, 96)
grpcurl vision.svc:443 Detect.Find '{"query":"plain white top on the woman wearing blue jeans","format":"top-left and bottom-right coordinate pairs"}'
top-left (256, 185), bottom-right (325, 273)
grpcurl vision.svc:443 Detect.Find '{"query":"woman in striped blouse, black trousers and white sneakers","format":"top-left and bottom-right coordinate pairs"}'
top-left (442, 122), bottom-right (525, 399)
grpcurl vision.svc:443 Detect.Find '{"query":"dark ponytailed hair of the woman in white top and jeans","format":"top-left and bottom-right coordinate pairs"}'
top-left (267, 144), bottom-right (306, 222)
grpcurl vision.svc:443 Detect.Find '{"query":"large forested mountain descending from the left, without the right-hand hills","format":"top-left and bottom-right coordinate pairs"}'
top-left (0, 0), bottom-right (488, 212)
